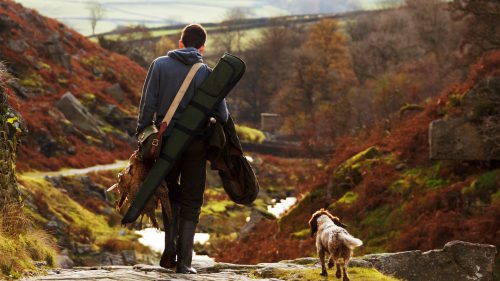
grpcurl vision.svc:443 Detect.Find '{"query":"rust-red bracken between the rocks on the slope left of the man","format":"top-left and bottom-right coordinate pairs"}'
top-left (0, 0), bottom-right (146, 171)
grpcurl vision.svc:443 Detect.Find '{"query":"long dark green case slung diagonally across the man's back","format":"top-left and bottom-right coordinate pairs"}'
top-left (122, 53), bottom-right (246, 224)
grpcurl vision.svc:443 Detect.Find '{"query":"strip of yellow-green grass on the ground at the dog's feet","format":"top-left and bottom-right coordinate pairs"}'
top-left (251, 267), bottom-right (399, 281)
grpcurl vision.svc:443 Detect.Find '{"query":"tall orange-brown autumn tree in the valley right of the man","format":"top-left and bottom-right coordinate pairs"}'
top-left (275, 20), bottom-right (356, 145)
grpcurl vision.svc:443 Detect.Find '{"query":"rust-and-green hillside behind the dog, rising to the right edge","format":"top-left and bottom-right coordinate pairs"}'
top-left (216, 52), bottom-right (500, 263)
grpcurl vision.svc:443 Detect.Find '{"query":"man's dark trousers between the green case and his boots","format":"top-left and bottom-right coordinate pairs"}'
top-left (166, 138), bottom-right (207, 222)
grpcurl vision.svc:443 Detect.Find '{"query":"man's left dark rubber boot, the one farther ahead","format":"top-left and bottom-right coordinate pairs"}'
top-left (160, 200), bottom-right (180, 268)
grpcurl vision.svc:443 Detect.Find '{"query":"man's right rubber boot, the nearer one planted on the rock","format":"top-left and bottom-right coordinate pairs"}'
top-left (175, 219), bottom-right (197, 274)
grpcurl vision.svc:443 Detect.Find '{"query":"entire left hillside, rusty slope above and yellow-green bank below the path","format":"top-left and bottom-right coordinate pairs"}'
top-left (0, 1), bottom-right (151, 279)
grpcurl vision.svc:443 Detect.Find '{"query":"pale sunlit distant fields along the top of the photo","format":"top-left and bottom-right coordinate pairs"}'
top-left (16, 0), bottom-right (383, 35)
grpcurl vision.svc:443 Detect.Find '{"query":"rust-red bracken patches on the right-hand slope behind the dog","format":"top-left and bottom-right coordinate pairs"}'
top-left (215, 51), bottom-right (500, 263)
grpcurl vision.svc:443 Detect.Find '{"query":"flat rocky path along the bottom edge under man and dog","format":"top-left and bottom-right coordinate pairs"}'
top-left (24, 241), bottom-right (497, 281)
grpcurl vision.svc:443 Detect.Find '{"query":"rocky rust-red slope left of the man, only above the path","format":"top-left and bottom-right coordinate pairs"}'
top-left (0, 0), bottom-right (146, 171)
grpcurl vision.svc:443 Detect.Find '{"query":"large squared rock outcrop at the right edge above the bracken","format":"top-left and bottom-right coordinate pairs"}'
top-left (429, 77), bottom-right (500, 161)
